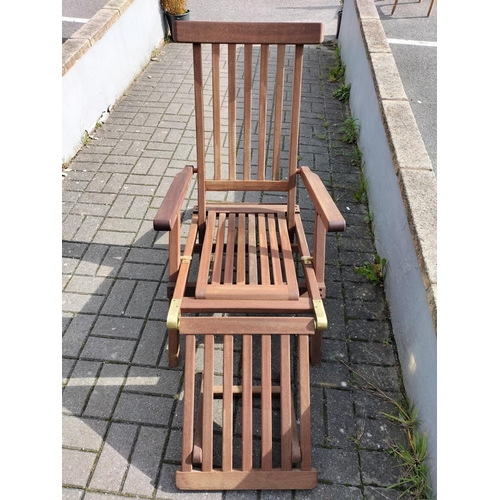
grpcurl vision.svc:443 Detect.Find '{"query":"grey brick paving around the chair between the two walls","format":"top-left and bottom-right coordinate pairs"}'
top-left (62, 39), bottom-right (412, 500)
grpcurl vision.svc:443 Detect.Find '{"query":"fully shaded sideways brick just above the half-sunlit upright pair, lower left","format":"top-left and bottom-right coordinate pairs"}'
top-left (114, 392), bottom-right (173, 426)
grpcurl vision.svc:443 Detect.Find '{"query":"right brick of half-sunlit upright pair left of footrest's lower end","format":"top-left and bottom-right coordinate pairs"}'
top-left (123, 427), bottom-right (167, 496)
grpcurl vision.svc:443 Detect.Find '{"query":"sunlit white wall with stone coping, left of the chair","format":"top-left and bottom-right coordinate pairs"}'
top-left (62, 0), bottom-right (165, 163)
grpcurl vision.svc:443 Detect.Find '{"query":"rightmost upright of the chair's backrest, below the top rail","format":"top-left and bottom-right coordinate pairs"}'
top-left (288, 45), bottom-right (304, 229)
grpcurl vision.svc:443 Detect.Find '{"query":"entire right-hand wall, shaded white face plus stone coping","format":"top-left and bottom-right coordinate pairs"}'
top-left (339, 0), bottom-right (437, 493)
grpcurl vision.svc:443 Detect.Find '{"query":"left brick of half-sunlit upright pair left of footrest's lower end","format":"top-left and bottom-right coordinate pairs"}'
top-left (90, 423), bottom-right (138, 492)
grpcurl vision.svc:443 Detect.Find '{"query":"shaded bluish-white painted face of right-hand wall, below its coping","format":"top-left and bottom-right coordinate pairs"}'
top-left (339, 0), bottom-right (437, 494)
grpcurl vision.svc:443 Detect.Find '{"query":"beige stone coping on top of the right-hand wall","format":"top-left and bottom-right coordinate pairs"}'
top-left (354, 0), bottom-right (437, 334)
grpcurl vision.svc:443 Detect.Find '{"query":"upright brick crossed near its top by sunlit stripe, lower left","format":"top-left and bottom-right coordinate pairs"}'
top-left (84, 363), bottom-right (128, 420)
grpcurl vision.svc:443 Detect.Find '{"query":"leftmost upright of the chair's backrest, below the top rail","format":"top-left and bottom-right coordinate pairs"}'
top-left (193, 43), bottom-right (206, 227)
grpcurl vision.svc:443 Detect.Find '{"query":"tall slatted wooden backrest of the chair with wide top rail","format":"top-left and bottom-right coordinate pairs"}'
top-left (173, 21), bottom-right (323, 225)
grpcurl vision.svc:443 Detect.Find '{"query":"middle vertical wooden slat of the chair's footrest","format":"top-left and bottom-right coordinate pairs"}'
top-left (241, 335), bottom-right (253, 471)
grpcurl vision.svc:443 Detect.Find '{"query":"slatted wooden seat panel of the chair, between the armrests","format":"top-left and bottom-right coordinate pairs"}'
top-left (195, 205), bottom-right (299, 301)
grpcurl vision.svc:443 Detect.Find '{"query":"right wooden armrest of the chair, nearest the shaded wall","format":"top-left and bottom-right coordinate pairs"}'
top-left (299, 167), bottom-right (345, 232)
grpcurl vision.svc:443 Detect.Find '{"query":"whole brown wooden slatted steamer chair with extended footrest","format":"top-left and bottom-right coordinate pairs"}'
top-left (154, 21), bottom-right (345, 490)
